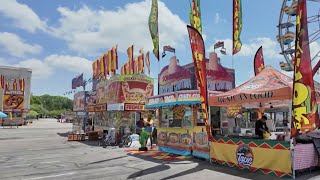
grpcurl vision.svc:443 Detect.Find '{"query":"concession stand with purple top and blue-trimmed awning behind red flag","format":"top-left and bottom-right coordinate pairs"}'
top-left (145, 53), bottom-right (234, 159)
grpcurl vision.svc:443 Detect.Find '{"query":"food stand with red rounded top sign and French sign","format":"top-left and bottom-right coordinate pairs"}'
top-left (95, 74), bottom-right (154, 132)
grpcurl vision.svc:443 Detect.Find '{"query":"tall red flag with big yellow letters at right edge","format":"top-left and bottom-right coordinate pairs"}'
top-left (291, 0), bottom-right (319, 137)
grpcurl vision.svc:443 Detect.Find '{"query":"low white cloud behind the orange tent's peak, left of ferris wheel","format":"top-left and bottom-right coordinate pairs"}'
top-left (209, 37), bottom-right (283, 60)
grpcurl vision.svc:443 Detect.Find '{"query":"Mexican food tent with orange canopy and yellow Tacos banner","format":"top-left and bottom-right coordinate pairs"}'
top-left (209, 66), bottom-right (319, 177)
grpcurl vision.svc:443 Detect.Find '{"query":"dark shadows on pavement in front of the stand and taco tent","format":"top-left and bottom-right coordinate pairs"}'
top-left (127, 149), bottom-right (320, 180)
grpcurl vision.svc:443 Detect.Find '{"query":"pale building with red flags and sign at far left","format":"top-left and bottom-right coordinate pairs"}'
top-left (0, 66), bottom-right (32, 119)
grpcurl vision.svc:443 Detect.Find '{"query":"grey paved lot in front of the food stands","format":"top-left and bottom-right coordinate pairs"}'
top-left (0, 119), bottom-right (320, 180)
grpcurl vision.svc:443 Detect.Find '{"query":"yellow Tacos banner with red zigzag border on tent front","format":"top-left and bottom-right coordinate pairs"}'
top-left (210, 136), bottom-right (292, 177)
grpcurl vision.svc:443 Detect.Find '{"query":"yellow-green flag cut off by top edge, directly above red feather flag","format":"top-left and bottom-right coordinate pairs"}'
top-left (190, 0), bottom-right (202, 34)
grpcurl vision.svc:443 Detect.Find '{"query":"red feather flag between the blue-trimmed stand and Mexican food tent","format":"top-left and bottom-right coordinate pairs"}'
top-left (187, 25), bottom-right (213, 140)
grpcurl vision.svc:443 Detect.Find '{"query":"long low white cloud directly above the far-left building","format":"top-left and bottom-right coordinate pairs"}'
top-left (0, 54), bottom-right (92, 79)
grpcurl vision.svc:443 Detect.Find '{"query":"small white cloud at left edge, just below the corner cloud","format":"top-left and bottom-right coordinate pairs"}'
top-left (0, 32), bottom-right (42, 57)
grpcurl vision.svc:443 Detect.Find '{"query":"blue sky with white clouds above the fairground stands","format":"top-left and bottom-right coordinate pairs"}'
top-left (0, 0), bottom-right (320, 97)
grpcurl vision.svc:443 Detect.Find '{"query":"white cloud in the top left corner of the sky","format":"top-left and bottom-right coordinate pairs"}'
top-left (0, 0), bottom-right (46, 32)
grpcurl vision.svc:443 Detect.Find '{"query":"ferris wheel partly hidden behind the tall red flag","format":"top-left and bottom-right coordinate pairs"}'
top-left (277, 0), bottom-right (320, 71)
